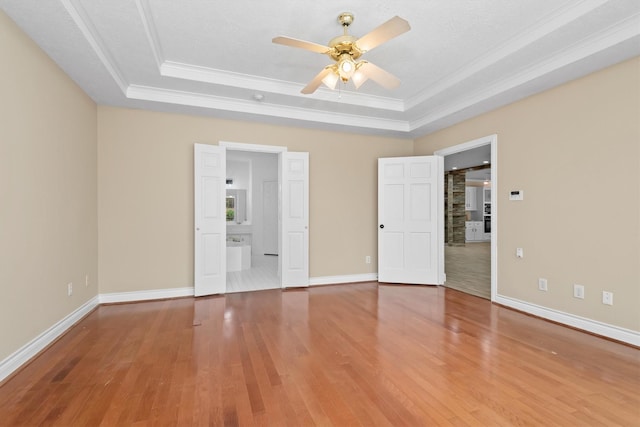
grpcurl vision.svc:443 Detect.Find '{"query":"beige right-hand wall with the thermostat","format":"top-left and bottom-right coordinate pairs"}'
top-left (415, 58), bottom-right (640, 331)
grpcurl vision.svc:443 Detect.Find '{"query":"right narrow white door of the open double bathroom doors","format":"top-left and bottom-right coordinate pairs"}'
top-left (281, 152), bottom-right (309, 287)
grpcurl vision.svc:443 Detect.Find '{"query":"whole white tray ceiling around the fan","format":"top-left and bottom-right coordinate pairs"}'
top-left (0, 0), bottom-right (640, 138)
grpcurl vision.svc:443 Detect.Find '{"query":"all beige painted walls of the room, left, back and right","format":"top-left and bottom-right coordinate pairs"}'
top-left (0, 3), bottom-right (640, 368)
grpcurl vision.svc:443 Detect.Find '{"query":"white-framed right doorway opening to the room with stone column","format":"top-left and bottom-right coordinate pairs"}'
top-left (435, 135), bottom-right (498, 301)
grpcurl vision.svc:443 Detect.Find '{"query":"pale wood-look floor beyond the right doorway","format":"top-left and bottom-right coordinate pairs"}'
top-left (444, 242), bottom-right (491, 300)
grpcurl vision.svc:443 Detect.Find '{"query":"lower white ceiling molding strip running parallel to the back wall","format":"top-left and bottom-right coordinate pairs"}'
top-left (126, 85), bottom-right (409, 133)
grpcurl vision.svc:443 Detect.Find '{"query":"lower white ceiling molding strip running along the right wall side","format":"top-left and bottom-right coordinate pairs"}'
top-left (410, 15), bottom-right (640, 131)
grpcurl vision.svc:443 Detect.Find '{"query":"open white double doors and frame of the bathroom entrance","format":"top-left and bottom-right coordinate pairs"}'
top-left (194, 141), bottom-right (309, 296)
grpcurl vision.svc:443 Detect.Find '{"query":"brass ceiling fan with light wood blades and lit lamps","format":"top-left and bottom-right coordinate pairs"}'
top-left (272, 12), bottom-right (411, 94)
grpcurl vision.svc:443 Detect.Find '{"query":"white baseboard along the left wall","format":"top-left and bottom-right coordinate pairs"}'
top-left (0, 296), bottom-right (98, 381)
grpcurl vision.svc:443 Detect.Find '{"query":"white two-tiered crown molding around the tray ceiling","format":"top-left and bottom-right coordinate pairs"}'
top-left (60, 0), bottom-right (640, 134)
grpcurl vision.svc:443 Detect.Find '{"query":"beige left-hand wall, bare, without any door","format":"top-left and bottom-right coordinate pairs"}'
top-left (0, 11), bottom-right (98, 360)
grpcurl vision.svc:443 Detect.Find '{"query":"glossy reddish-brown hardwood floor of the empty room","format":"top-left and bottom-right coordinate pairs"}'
top-left (0, 283), bottom-right (640, 426)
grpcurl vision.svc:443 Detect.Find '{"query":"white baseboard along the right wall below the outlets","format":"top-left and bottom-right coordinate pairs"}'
top-left (494, 295), bottom-right (640, 346)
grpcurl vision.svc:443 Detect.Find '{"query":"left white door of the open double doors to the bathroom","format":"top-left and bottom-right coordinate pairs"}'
top-left (194, 144), bottom-right (227, 296)
